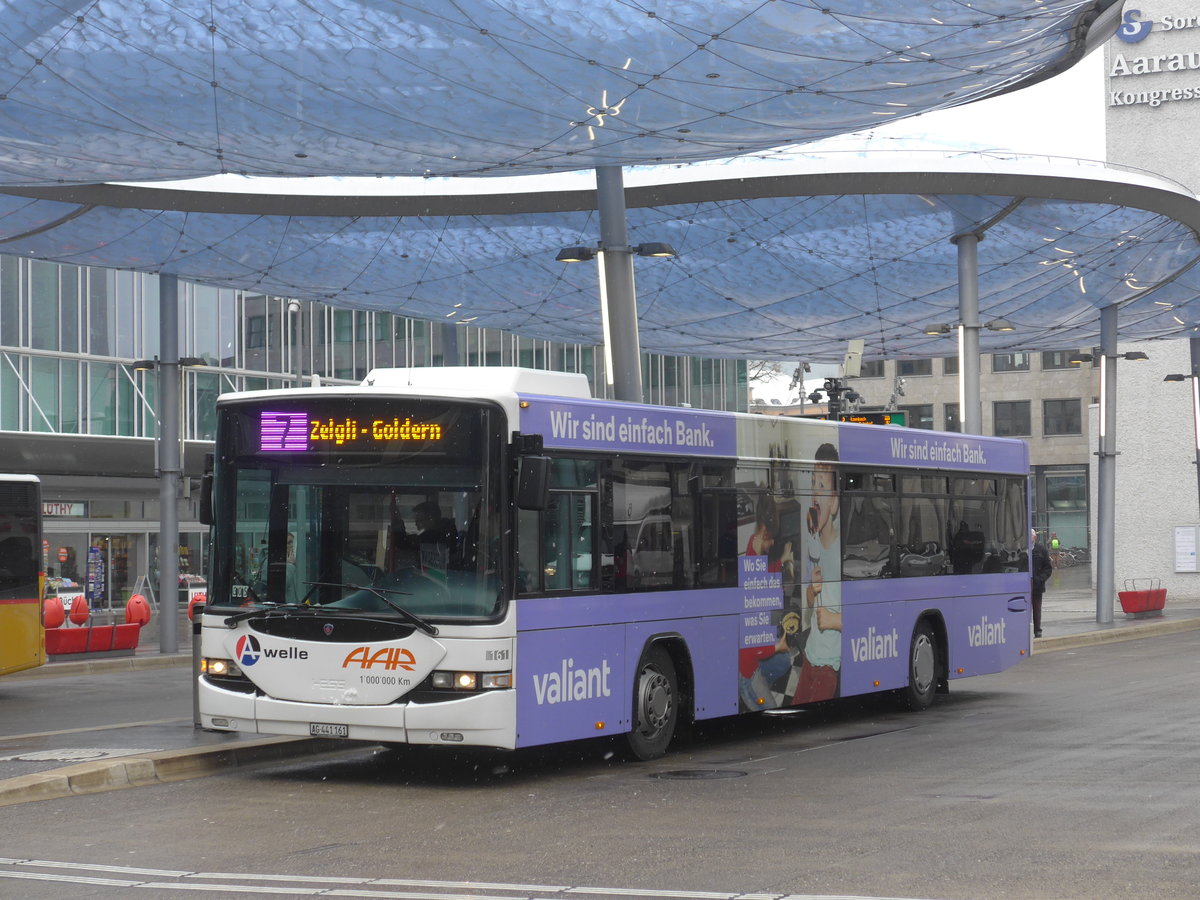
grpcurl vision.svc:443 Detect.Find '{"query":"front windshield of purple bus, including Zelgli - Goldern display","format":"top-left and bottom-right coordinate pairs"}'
top-left (210, 398), bottom-right (503, 620)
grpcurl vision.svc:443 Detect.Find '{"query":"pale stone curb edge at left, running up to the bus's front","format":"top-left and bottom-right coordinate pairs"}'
top-left (0, 737), bottom-right (347, 806)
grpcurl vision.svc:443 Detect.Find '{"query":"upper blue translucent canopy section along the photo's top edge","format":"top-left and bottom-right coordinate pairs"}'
top-left (0, 0), bottom-right (1120, 185)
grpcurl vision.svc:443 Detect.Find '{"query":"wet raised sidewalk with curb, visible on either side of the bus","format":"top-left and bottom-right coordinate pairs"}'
top-left (0, 566), bottom-right (1200, 806)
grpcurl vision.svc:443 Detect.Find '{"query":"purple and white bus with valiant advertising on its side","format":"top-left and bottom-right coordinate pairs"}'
top-left (199, 368), bottom-right (1030, 758)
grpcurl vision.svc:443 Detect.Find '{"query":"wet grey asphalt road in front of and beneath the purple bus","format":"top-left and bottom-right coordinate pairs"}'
top-left (0, 634), bottom-right (1200, 900)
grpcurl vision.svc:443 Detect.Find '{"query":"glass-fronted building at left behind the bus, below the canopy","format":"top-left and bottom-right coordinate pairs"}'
top-left (0, 250), bottom-right (749, 608)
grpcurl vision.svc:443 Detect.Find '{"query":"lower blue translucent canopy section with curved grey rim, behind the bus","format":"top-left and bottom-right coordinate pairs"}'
top-left (0, 154), bottom-right (1200, 361)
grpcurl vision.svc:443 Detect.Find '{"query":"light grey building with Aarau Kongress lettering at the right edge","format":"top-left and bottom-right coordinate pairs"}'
top-left (1090, 0), bottom-right (1200, 602)
